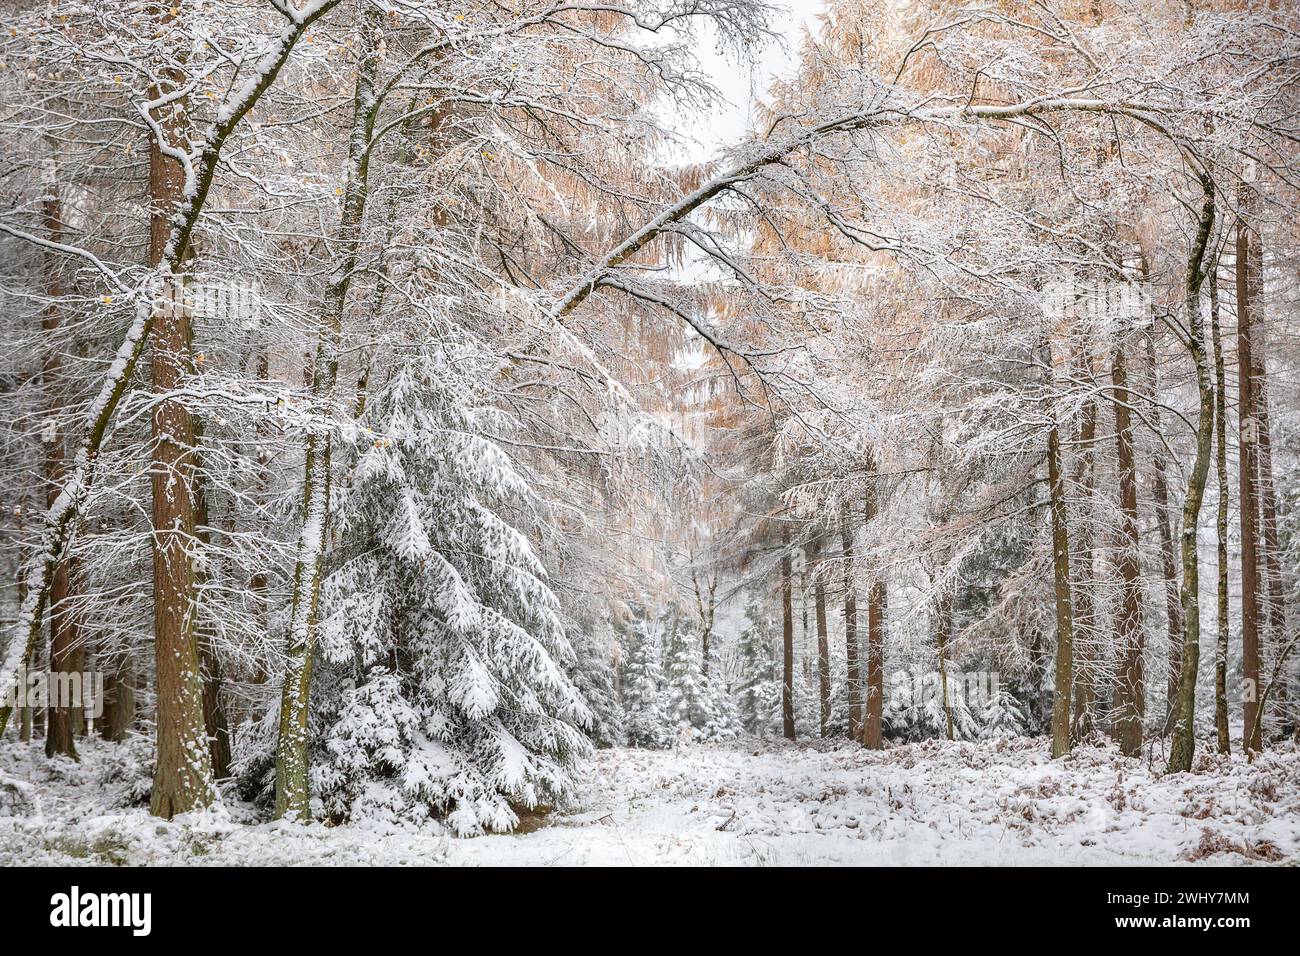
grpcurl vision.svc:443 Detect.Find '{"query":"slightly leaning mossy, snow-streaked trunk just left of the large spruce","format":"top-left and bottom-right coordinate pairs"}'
top-left (276, 5), bottom-right (382, 821)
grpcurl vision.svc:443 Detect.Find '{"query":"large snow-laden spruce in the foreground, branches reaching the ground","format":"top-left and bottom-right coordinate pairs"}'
top-left (312, 342), bottom-right (592, 835)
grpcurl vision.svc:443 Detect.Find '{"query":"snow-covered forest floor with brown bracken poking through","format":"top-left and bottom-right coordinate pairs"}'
top-left (0, 739), bottom-right (1300, 866)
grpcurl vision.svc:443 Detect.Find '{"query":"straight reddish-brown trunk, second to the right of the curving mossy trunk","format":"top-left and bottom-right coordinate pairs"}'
top-left (1235, 204), bottom-right (1261, 750)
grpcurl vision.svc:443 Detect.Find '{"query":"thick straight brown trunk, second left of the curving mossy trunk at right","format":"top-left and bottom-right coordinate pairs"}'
top-left (1110, 338), bottom-right (1147, 757)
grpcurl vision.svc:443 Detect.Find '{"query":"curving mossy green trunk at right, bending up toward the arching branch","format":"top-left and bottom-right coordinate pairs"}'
top-left (1169, 173), bottom-right (1214, 774)
